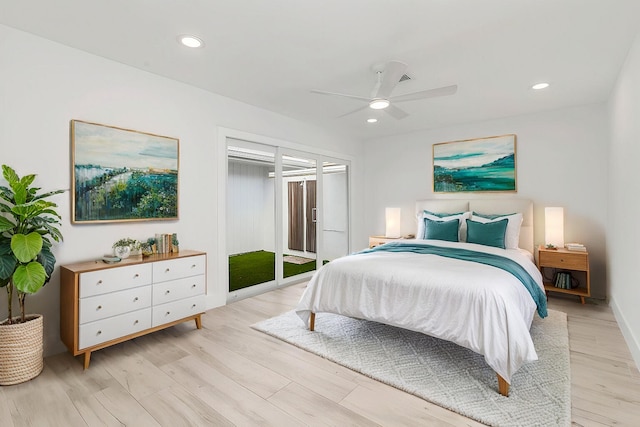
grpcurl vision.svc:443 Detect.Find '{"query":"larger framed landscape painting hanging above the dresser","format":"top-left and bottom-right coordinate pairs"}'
top-left (72, 120), bottom-right (178, 222)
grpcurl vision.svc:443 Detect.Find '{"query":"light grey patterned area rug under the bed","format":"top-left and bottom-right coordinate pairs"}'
top-left (252, 310), bottom-right (571, 426)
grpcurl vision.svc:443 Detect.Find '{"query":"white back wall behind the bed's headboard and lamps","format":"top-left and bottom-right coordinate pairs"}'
top-left (362, 105), bottom-right (608, 298)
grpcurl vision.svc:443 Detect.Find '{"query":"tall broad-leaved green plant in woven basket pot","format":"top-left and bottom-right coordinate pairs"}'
top-left (0, 165), bottom-right (64, 385)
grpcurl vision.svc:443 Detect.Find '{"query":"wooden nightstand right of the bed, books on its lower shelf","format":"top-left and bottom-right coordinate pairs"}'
top-left (538, 246), bottom-right (591, 304)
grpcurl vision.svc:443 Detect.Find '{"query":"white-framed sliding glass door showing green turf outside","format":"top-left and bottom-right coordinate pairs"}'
top-left (226, 139), bottom-right (349, 297)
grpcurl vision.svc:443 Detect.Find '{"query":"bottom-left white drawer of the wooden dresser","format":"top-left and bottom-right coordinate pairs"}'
top-left (78, 308), bottom-right (151, 350)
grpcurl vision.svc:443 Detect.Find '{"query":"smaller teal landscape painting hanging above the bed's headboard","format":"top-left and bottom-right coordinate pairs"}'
top-left (433, 135), bottom-right (516, 193)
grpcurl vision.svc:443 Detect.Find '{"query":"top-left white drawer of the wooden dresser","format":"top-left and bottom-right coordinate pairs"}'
top-left (79, 264), bottom-right (152, 298)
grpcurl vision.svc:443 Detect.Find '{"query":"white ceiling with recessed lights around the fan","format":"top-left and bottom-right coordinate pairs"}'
top-left (0, 0), bottom-right (640, 140)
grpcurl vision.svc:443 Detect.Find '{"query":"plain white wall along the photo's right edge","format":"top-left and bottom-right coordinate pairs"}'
top-left (607, 34), bottom-right (640, 366)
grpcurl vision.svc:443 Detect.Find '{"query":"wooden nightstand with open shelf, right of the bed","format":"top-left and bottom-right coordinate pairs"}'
top-left (538, 246), bottom-right (591, 304)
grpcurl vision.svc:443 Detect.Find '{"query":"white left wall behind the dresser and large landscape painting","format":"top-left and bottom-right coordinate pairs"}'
top-left (0, 25), bottom-right (360, 354)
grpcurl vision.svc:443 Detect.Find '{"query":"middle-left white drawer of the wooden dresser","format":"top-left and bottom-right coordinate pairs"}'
top-left (78, 285), bottom-right (152, 324)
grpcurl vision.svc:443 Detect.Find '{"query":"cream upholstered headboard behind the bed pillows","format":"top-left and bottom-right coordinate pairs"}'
top-left (416, 198), bottom-right (534, 253)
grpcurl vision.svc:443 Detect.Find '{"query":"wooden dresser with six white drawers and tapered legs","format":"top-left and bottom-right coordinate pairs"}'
top-left (60, 251), bottom-right (207, 369)
